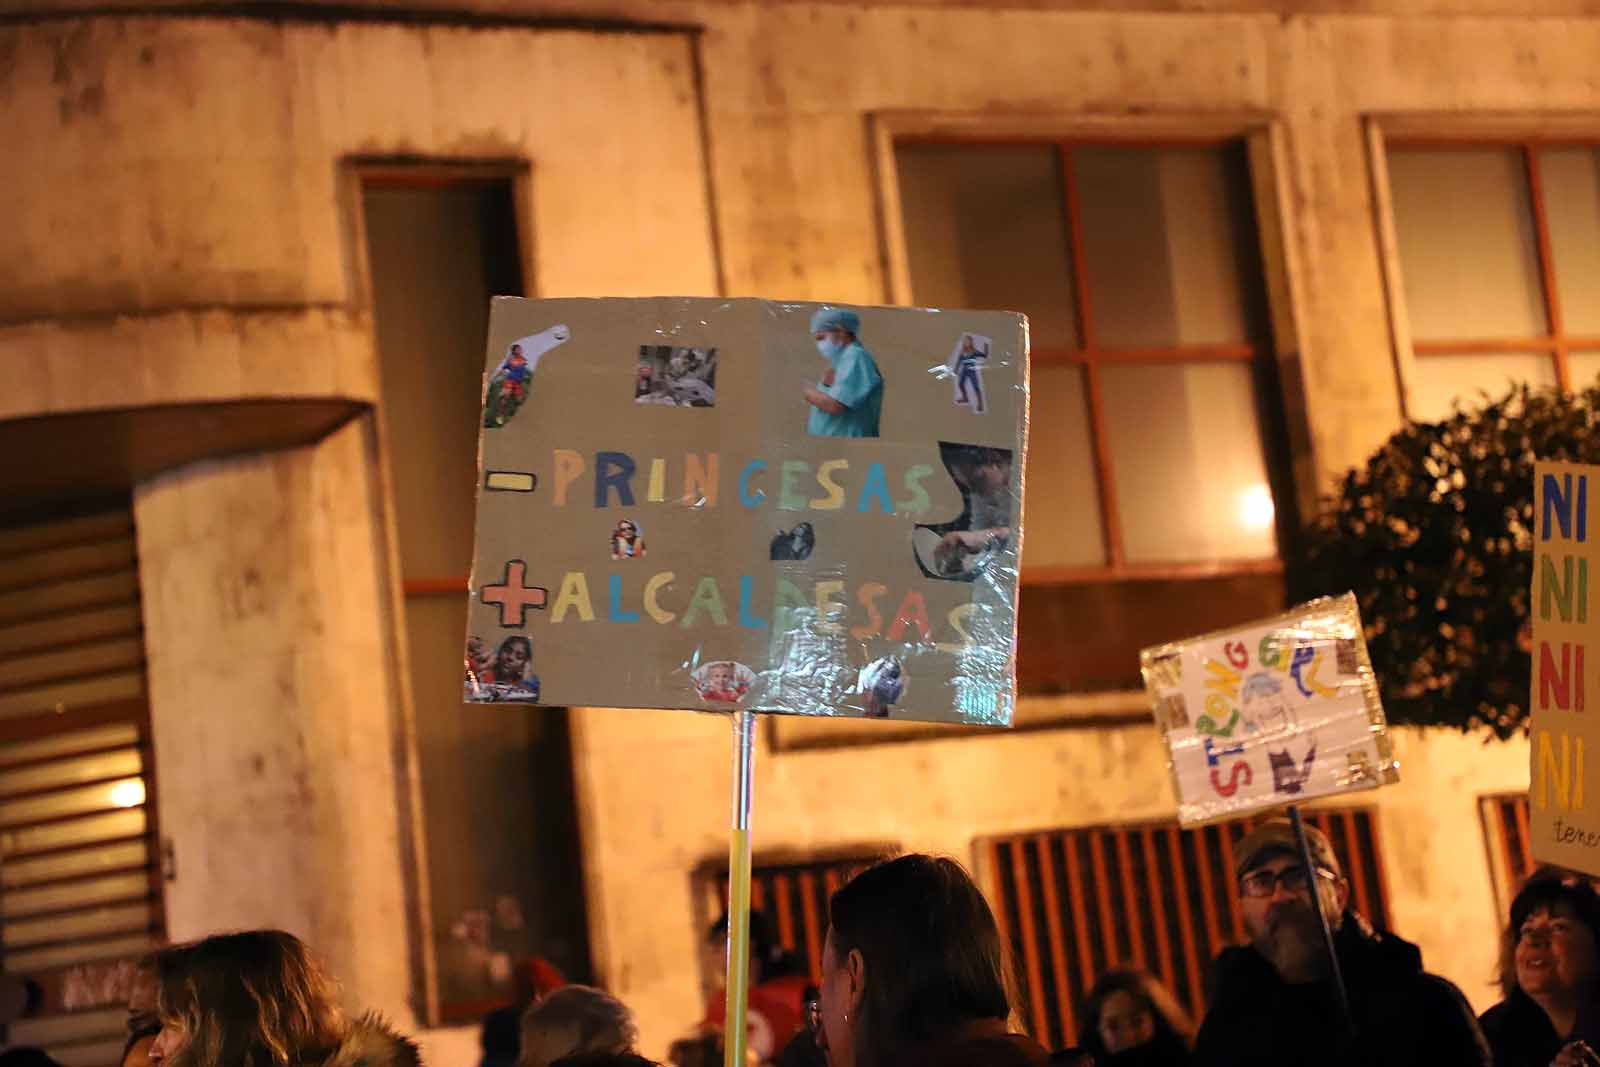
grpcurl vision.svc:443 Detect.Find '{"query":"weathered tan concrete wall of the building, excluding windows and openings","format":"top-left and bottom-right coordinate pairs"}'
top-left (0, 0), bottom-right (1600, 1062)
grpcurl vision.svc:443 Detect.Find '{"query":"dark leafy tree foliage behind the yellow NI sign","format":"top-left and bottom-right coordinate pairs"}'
top-left (1290, 386), bottom-right (1600, 739)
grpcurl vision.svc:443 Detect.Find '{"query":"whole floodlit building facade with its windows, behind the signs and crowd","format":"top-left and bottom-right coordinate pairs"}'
top-left (0, 0), bottom-right (1600, 1064)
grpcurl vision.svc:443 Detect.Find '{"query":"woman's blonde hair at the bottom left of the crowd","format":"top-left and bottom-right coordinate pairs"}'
top-left (155, 929), bottom-right (344, 1067)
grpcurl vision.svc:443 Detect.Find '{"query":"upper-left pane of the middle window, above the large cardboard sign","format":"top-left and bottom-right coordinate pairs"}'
top-left (894, 144), bottom-right (1077, 349)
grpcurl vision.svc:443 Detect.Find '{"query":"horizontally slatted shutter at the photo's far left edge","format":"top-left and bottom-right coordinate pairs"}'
top-left (0, 506), bottom-right (163, 1067)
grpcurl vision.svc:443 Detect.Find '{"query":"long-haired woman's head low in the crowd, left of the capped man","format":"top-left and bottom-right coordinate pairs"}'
top-left (1078, 968), bottom-right (1194, 1067)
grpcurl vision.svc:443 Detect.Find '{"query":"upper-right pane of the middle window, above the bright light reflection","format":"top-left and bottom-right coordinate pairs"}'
top-left (1072, 146), bottom-right (1258, 347)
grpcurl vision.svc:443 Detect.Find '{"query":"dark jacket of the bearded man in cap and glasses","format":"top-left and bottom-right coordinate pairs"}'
top-left (1194, 912), bottom-right (1490, 1067)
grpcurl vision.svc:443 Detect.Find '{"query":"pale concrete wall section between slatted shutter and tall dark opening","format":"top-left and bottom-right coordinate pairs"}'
top-left (134, 419), bottom-right (411, 1019)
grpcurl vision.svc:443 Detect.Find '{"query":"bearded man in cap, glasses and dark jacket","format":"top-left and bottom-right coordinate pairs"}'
top-left (1194, 819), bottom-right (1490, 1067)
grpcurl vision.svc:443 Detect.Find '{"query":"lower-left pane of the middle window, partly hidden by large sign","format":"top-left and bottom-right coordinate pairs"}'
top-left (1022, 365), bottom-right (1106, 573)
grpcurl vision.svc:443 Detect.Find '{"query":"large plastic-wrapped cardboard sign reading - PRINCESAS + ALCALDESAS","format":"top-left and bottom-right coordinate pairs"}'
top-left (466, 298), bottom-right (1027, 726)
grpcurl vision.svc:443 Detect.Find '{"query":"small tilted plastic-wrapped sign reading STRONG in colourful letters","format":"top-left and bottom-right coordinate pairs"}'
top-left (1141, 593), bottom-right (1400, 825)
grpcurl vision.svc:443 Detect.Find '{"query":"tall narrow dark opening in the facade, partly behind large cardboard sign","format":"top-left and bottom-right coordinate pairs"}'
top-left (362, 166), bottom-right (590, 1022)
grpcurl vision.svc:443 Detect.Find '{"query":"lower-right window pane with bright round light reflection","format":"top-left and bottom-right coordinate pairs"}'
top-left (1101, 363), bottom-right (1277, 563)
